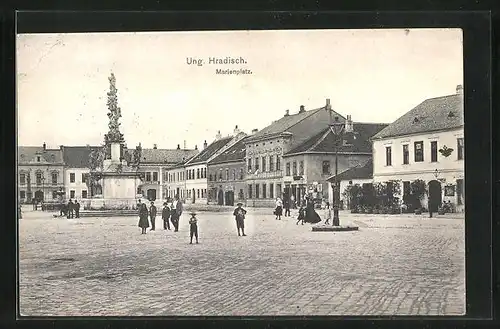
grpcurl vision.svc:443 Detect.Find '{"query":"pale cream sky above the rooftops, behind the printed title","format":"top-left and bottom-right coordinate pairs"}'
top-left (16, 29), bottom-right (463, 148)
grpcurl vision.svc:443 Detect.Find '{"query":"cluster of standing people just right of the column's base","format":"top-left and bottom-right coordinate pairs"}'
top-left (137, 196), bottom-right (183, 234)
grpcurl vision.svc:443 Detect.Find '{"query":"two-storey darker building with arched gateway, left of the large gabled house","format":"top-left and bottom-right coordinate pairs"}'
top-left (207, 137), bottom-right (247, 206)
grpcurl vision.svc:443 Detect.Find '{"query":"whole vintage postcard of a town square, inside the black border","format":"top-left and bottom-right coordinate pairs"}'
top-left (17, 29), bottom-right (465, 316)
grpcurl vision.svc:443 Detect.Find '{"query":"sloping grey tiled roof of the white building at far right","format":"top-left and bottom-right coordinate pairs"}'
top-left (373, 94), bottom-right (464, 139)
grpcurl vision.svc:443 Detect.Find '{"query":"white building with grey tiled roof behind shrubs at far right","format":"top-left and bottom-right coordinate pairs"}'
top-left (372, 85), bottom-right (465, 212)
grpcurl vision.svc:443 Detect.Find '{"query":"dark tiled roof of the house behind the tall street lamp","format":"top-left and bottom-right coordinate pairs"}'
top-left (285, 122), bottom-right (387, 156)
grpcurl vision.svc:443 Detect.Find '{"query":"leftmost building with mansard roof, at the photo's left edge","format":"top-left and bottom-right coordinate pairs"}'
top-left (17, 143), bottom-right (65, 203)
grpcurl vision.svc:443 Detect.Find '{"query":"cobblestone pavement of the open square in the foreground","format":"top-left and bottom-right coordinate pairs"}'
top-left (19, 209), bottom-right (465, 316)
